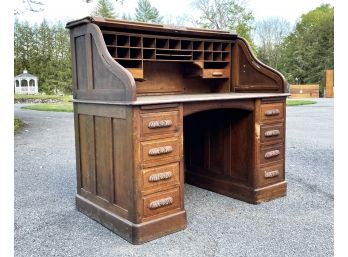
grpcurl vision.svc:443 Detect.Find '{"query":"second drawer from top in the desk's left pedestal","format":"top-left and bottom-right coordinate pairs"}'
top-left (140, 137), bottom-right (181, 163)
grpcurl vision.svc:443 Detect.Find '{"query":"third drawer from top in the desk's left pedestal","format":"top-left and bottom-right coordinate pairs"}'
top-left (142, 162), bottom-right (180, 190)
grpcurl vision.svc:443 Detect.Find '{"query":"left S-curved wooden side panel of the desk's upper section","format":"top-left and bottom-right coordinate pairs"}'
top-left (70, 23), bottom-right (136, 101)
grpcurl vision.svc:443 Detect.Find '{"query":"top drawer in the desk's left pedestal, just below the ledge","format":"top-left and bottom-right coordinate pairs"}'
top-left (140, 110), bottom-right (180, 137)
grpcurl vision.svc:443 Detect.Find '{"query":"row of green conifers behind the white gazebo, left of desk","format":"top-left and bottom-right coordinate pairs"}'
top-left (14, 20), bottom-right (72, 94)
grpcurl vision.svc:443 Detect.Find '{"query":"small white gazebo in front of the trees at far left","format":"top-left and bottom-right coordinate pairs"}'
top-left (14, 70), bottom-right (39, 95)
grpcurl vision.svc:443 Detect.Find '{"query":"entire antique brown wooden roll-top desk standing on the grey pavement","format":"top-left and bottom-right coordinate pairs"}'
top-left (67, 17), bottom-right (289, 244)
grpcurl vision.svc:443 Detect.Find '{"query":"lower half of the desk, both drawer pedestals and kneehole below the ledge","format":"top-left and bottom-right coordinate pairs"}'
top-left (74, 97), bottom-right (286, 244)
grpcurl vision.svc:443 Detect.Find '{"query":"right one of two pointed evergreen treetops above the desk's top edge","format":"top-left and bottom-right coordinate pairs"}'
top-left (135, 0), bottom-right (163, 23)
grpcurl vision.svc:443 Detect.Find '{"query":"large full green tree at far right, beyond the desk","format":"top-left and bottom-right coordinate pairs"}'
top-left (279, 4), bottom-right (334, 93)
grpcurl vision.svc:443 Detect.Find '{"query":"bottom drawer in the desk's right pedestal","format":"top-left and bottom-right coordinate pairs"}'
top-left (259, 162), bottom-right (284, 186)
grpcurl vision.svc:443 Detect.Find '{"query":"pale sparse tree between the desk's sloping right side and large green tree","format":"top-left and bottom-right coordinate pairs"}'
top-left (255, 17), bottom-right (290, 69)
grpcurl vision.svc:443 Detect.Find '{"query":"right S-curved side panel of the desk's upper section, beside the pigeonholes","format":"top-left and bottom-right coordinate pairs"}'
top-left (232, 37), bottom-right (289, 93)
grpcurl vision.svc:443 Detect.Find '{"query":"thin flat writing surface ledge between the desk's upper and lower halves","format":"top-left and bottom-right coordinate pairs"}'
top-left (73, 93), bottom-right (290, 105)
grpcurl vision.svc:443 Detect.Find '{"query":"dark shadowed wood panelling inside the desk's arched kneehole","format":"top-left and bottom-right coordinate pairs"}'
top-left (184, 109), bottom-right (253, 180)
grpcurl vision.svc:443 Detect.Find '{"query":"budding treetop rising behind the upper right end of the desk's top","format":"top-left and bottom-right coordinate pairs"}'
top-left (193, 0), bottom-right (254, 46)
